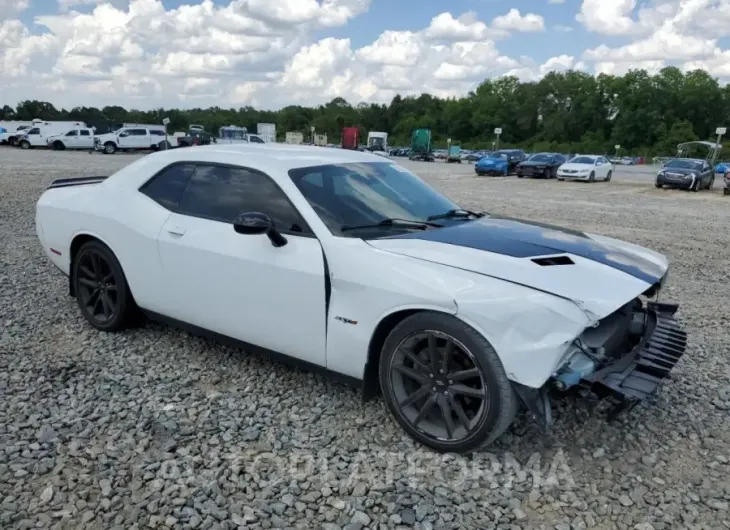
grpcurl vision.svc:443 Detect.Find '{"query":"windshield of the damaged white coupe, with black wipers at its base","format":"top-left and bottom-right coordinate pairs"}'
top-left (289, 162), bottom-right (463, 237)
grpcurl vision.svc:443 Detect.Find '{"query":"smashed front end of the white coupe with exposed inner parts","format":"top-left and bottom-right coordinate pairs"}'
top-left (514, 298), bottom-right (687, 431)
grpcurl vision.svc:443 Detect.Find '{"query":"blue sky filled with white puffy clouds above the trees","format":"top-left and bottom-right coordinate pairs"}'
top-left (0, 0), bottom-right (730, 110)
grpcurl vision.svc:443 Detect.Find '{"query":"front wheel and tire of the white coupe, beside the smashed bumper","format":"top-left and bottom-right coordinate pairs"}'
top-left (379, 311), bottom-right (517, 454)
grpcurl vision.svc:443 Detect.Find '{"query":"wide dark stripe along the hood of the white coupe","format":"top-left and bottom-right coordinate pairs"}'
top-left (386, 217), bottom-right (664, 285)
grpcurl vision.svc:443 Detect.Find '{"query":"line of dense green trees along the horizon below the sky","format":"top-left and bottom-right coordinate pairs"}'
top-left (0, 67), bottom-right (730, 156)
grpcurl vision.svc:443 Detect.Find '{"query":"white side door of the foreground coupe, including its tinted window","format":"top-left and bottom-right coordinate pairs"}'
top-left (158, 163), bottom-right (326, 366)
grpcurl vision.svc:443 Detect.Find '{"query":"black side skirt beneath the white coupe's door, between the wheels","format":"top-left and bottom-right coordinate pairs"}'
top-left (142, 309), bottom-right (362, 388)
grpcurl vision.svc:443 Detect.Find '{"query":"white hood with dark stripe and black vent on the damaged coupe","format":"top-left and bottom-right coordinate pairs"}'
top-left (368, 216), bottom-right (668, 319)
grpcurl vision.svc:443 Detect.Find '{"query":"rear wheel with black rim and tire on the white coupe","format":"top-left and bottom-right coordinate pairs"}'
top-left (71, 241), bottom-right (137, 332)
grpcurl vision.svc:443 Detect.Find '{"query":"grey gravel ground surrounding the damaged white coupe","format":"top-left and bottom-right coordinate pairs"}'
top-left (0, 149), bottom-right (730, 530)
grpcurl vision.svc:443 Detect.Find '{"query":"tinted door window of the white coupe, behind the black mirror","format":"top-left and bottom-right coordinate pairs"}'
top-left (179, 164), bottom-right (310, 233)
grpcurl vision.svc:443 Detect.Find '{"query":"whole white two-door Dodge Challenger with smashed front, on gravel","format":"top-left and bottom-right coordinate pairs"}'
top-left (36, 144), bottom-right (687, 453)
